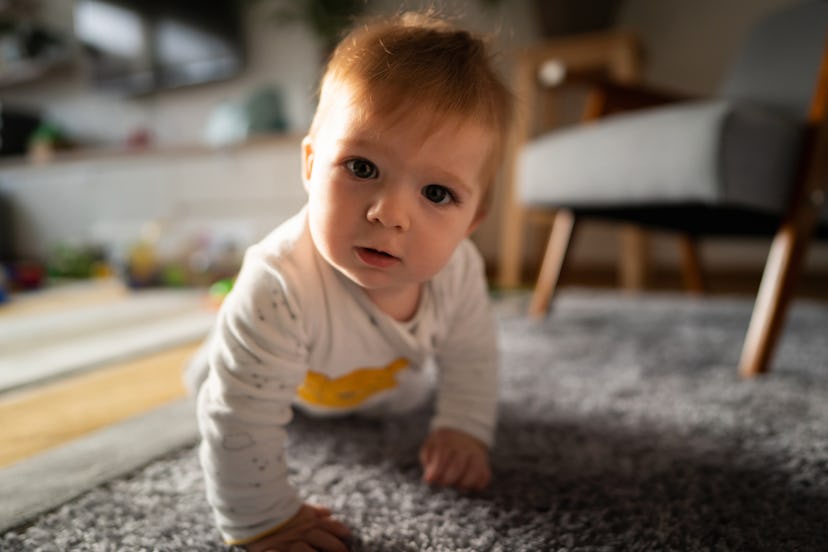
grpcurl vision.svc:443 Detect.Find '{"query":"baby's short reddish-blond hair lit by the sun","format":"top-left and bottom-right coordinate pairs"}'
top-left (310, 13), bottom-right (513, 211)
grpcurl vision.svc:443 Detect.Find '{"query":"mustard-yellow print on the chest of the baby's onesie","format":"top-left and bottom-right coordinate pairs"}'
top-left (298, 358), bottom-right (408, 408)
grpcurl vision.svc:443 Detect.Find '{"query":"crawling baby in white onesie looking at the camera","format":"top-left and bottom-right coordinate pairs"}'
top-left (193, 10), bottom-right (512, 552)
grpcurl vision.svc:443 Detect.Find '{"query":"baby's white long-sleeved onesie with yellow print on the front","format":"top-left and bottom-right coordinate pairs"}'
top-left (198, 209), bottom-right (498, 544)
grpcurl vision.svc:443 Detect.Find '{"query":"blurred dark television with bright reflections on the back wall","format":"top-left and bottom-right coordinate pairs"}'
top-left (74, 0), bottom-right (245, 95)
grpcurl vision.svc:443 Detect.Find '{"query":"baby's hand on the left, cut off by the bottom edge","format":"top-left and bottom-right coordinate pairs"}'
top-left (245, 504), bottom-right (351, 552)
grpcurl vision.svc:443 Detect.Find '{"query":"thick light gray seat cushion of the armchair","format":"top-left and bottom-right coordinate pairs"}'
top-left (518, 100), bottom-right (802, 218)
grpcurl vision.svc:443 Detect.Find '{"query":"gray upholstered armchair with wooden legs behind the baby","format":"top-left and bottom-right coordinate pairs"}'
top-left (498, 0), bottom-right (828, 376)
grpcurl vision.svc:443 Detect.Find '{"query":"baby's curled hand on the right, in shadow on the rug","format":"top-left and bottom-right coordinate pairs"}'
top-left (420, 428), bottom-right (492, 490)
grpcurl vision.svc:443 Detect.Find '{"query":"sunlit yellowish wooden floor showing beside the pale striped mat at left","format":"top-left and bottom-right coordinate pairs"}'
top-left (0, 281), bottom-right (207, 468)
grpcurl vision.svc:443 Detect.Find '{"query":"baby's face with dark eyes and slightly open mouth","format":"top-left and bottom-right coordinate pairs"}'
top-left (303, 98), bottom-right (492, 310)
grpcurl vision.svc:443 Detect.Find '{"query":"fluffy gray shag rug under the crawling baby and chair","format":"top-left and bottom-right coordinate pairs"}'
top-left (0, 291), bottom-right (828, 552)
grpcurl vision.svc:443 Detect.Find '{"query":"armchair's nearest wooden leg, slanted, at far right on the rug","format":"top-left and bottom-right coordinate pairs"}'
top-left (739, 218), bottom-right (810, 378)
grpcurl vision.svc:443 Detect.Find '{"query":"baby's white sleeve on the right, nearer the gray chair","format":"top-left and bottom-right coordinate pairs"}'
top-left (432, 242), bottom-right (499, 446)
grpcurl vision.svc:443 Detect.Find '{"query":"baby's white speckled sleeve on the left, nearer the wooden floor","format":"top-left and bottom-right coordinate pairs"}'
top-left (198, 253), bottom-right (308, 544)
